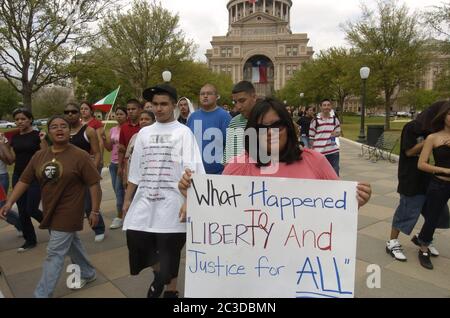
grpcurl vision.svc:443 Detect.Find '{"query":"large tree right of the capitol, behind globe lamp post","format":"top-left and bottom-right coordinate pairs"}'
top-left (344, 0), bottom-right (427, 129)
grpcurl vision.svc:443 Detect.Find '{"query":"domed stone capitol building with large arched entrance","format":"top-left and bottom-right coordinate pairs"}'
top-left (206, 0), bottom-right (314, 96)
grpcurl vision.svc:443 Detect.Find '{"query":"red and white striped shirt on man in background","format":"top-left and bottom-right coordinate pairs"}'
top-left (309, 115), bottom-right (341, 156)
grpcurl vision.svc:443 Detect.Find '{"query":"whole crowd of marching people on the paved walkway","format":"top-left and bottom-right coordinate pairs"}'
top-left (0, 81), bottom-right (450, 298)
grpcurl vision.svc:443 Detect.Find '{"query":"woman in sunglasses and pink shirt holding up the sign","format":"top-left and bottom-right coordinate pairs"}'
top-left (178, 98), bottom-right (372, 219)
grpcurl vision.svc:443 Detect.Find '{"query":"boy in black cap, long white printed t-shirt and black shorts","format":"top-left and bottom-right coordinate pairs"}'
top-left (123, 84), bottom-right (205, 298)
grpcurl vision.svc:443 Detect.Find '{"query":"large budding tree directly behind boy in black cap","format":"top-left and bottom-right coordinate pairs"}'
top-left (97, 0), bottom-right (195, 96)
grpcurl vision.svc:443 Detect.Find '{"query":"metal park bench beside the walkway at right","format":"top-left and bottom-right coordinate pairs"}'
top-left (360, 133), bottom-right (400, 163)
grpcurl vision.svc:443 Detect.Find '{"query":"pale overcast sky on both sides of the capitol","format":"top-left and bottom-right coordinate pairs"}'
top-left (118, 0), bottom-right (446, 61)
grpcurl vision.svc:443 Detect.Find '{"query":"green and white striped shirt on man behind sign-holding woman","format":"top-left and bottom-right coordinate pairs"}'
top-left (223, 114), bottom-right (247, 165)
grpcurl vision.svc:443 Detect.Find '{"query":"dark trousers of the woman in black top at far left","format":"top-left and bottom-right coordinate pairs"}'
top-left (12, 174), bottom-right (43, 244)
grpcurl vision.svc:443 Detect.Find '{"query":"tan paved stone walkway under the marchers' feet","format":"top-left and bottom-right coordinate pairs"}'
top-left (0, 141), bottom-right (450, 298)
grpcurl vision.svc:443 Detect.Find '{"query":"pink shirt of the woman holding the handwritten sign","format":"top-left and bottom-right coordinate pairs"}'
top-left (223, 149), bottom-right (339, 180)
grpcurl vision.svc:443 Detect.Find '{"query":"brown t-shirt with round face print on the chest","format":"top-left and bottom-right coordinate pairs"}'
top-left (20, 145), bottom-right (101, 232)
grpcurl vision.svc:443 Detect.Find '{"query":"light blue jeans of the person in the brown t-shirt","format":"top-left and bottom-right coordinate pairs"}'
top-left (34, 231), bottom-right (96, 298)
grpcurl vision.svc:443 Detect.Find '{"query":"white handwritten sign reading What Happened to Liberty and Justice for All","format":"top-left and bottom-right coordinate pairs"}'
top-left (185, 175), bottom-right (358, 298)
